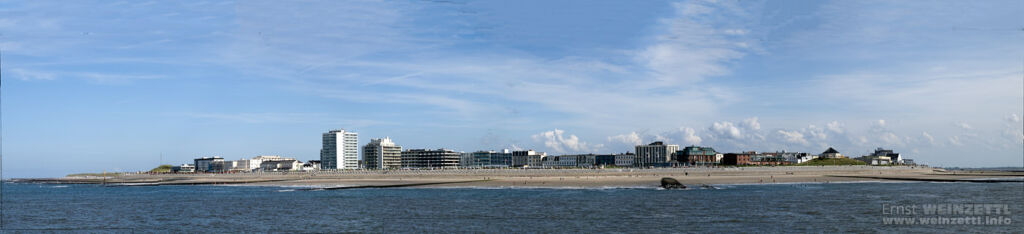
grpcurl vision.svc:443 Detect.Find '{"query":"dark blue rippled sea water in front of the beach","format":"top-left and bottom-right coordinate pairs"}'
top-left (2, 180), bottom-right (1024, 233)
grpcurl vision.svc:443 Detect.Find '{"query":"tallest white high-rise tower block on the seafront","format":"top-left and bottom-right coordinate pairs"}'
top-left (321, 130), bottom-right (359, 170)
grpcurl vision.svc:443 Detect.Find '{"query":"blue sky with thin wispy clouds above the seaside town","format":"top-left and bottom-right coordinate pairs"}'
top-left (0, 0), bottom-right (1024, 178)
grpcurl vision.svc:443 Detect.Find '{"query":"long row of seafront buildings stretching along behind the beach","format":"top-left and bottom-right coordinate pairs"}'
top-left (163, 130), bottom-right (913, 173)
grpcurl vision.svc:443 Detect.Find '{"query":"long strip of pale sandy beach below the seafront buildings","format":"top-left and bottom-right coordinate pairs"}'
top-left (19, 166), bottom-right (1024, 188)
